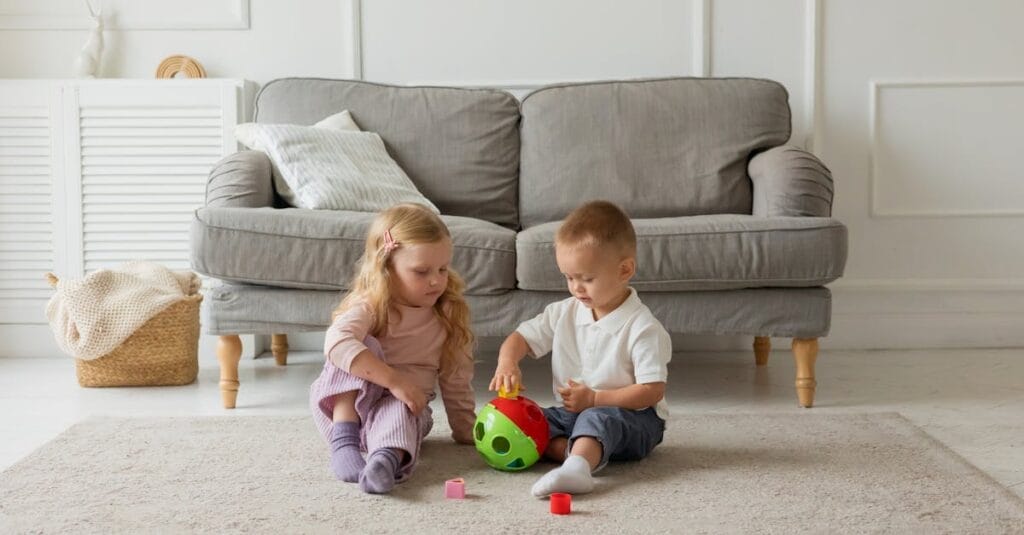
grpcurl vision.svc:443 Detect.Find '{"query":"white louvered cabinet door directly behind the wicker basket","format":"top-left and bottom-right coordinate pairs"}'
top-left (71, 80), bottom-right (240, 273)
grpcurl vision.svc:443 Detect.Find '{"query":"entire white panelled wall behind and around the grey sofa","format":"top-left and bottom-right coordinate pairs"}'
top-left (0, 0), bottom-right (1024, 347)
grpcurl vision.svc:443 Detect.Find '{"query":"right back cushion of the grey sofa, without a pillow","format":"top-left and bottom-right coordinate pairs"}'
top-left (519, 78), bottom-right (791, 227)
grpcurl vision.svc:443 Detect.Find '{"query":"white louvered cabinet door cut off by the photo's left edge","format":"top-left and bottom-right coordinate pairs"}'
top-left (0, 81), bottom-right (67, 324)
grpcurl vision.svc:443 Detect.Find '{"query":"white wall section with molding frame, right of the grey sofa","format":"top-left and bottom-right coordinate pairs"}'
top-left (819, 0), bottom-right (1024, 346)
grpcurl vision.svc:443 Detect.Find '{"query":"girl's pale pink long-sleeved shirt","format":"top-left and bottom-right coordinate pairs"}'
top-left (324, 295), bottom-right (476, 444)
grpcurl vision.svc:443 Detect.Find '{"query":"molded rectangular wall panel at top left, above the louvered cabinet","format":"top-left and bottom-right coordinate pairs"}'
top-left (0, 0), bottom-right (249, 32)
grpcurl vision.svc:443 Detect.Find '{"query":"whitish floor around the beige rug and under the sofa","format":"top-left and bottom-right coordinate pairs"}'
top-left (0, 349), bottom-right (1024, 497)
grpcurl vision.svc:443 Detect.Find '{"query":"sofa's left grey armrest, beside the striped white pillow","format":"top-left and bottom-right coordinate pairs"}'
top-left (206, 151), bottom-right (273, 208)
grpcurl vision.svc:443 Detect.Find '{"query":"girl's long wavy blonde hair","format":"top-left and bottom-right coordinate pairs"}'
top-left (331, 203), bottom-right (473, 370)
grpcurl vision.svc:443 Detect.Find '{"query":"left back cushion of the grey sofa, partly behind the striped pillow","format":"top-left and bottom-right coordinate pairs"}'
top-left (254, 78), bottom-right (519, 228)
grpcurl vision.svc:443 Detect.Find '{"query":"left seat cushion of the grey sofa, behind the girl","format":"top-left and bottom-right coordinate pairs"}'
top-left (190, 206), bottom-right (515, 295)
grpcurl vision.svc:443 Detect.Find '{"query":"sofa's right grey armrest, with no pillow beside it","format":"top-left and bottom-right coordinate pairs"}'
top-left (746, 145), bottom-right (834, 217)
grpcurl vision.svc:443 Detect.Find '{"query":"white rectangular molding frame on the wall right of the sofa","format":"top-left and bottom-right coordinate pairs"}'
top-left (867, 78), bottom-right (1024, 219)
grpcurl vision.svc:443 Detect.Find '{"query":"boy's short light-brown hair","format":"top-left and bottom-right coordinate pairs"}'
top-left (555, 201), bottom-right (637, 257)
